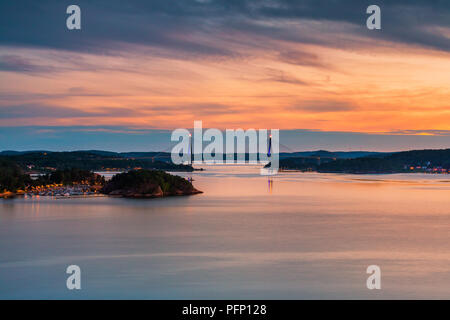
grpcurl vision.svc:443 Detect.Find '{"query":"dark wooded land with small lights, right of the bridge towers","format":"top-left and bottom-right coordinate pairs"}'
top-left (268, 149), bottom-right (450, 174)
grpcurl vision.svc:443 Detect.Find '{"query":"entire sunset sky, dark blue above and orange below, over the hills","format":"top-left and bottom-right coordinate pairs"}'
top-left (0, 0), bottom-right (450, 151)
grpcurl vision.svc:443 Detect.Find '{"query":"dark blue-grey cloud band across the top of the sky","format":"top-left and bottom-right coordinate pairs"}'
top-left (0, 0), bottom-right (450, 58)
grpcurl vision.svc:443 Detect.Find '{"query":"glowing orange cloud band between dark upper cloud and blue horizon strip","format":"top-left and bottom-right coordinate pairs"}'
top-left (0, 36), bottom-right (450, 132)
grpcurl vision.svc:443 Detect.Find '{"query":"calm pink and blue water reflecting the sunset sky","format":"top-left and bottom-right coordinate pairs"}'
top-left (0, 166), bottom-right (450, 299)
